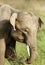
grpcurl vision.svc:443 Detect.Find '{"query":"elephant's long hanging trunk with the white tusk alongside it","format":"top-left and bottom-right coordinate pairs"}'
top-left (26, 31), bottom-right (37, 63)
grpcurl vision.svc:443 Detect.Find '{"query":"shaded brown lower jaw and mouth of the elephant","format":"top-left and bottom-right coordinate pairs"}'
top-left (11, 30), bottom-right (24, 42)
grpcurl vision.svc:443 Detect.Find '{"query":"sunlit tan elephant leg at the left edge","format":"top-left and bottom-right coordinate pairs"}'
top-left (0, 39), bottom-right (5, 65)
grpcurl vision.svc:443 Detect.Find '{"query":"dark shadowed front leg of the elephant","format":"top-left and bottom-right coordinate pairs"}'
top-left (5, 37), bottom-right (16, 62)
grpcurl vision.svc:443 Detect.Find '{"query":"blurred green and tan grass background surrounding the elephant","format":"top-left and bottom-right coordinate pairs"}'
top-left (0, 0), bottom-right (45, 65)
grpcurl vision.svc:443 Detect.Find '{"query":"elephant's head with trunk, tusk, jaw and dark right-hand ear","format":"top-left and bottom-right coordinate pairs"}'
top-left (12, 11), bottom-right (43, 63)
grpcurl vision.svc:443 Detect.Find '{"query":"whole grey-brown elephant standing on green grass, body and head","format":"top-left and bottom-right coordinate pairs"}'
top-left (0, 5), bottom-right (42, 65)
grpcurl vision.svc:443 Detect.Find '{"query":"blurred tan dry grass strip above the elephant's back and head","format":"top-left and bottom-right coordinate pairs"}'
top-left (0, 0), bottom-right (45, 11)
